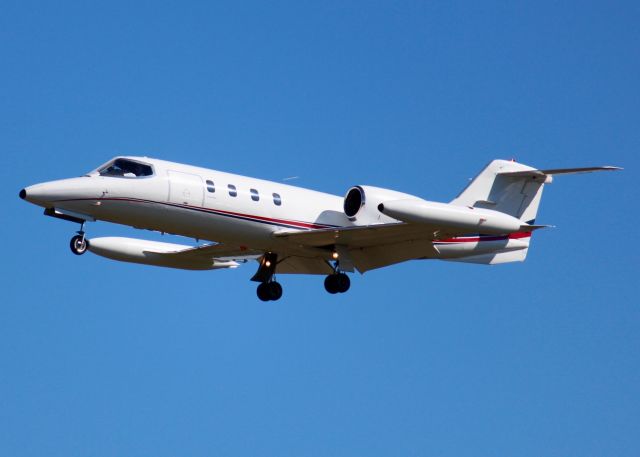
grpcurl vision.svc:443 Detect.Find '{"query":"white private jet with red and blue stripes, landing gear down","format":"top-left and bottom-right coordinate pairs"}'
top-left (19, 156), bottom-right (621, 301)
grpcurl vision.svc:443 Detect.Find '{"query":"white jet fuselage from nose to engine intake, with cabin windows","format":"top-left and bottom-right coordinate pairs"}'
top-left (28, 158), bottom-right (350, 250)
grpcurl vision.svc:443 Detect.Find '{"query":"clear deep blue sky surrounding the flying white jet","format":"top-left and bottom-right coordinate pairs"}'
top-left (0, 1), bottom-right (640, 457)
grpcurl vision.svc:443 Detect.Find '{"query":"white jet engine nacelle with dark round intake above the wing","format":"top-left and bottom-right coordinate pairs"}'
top-left (344, 186), bottom-right (422, 225)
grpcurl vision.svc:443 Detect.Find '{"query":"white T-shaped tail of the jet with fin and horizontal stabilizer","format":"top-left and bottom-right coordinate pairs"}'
top-left (446, 160), bottom-right (621, 265)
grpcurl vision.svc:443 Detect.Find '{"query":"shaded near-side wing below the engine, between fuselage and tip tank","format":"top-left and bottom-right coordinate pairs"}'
top-left (274, 223), bottom-right (452, 273)
